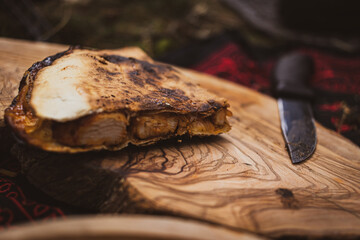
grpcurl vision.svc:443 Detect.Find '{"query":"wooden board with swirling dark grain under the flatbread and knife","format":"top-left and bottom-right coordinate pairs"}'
top-left (0, 39), bottom-right (360, 237)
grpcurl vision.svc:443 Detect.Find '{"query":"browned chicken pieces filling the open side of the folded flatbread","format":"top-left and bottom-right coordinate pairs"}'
top-left (52, 109), bottom-right (227, 147)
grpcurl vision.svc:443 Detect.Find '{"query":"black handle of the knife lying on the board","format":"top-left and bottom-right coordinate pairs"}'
top-left (273, 53), bottom-right (314, 99)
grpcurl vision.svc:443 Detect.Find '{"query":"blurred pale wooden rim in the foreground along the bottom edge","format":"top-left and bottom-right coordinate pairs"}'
top-left (0, 215), bottom-right (263, 240)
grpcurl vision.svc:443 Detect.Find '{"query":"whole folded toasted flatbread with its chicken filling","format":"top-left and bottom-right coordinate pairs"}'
top-left (5, 48), bottom-right (231, 152)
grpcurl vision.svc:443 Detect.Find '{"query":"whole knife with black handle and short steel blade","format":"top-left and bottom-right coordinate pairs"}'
top-left (273, 53), bottom-right (317, 163)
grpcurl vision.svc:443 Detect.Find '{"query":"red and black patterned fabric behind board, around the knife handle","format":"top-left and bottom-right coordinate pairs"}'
top-left (193, 42), bottom-right (360, 138)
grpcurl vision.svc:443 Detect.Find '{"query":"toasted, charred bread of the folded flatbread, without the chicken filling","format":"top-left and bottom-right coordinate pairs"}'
top-left (5, 48), bottom-right (230, 152)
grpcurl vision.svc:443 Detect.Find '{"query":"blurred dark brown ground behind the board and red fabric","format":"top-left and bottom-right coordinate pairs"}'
top-left (0, 0), bottom-right (360, 57)
